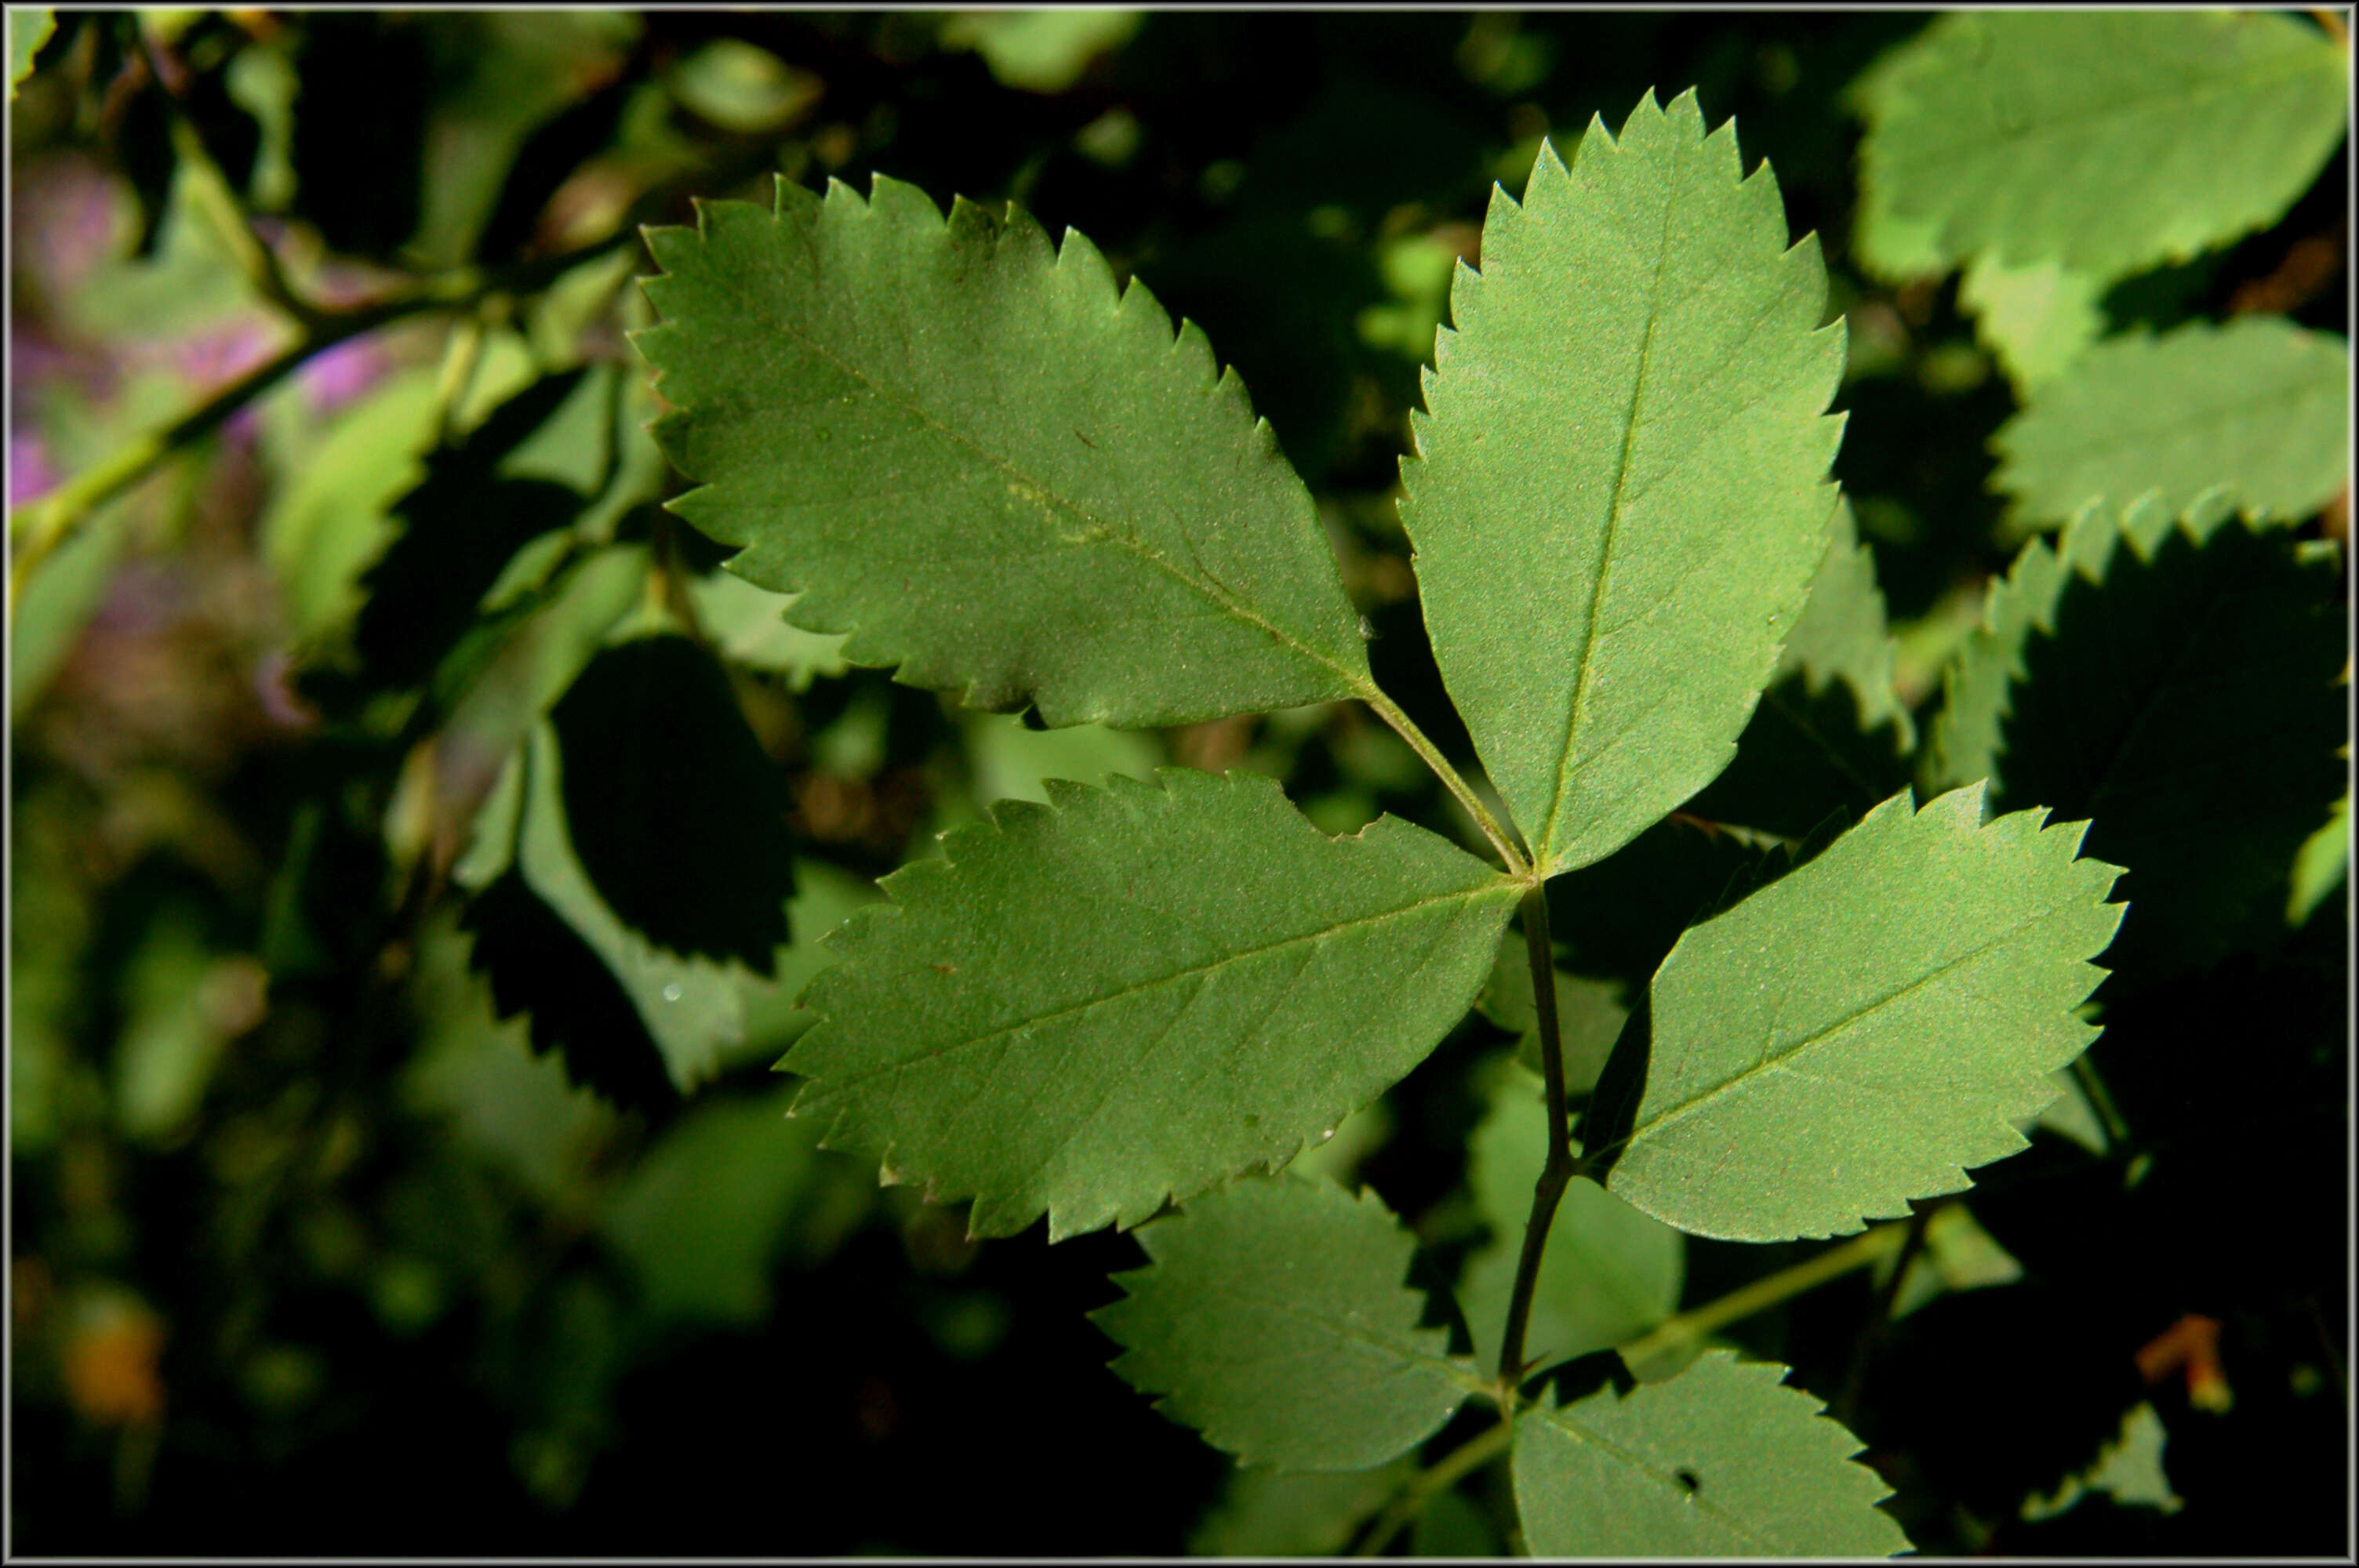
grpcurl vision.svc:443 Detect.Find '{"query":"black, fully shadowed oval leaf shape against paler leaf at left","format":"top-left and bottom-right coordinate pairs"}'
top-left (550, 634), bottom-right (795, 974)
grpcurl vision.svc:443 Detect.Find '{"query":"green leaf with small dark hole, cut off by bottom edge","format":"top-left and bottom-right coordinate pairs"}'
top-left (1514, 1351), bottom-right (1908, 1556)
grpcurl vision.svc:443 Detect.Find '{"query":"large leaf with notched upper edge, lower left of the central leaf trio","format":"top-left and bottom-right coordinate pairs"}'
top-left (786, 768), bottom-right (1517, 1240)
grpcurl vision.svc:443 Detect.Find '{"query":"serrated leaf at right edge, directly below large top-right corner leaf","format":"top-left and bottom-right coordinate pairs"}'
top-left (1991, 316), bottom-right (2350, 526)
